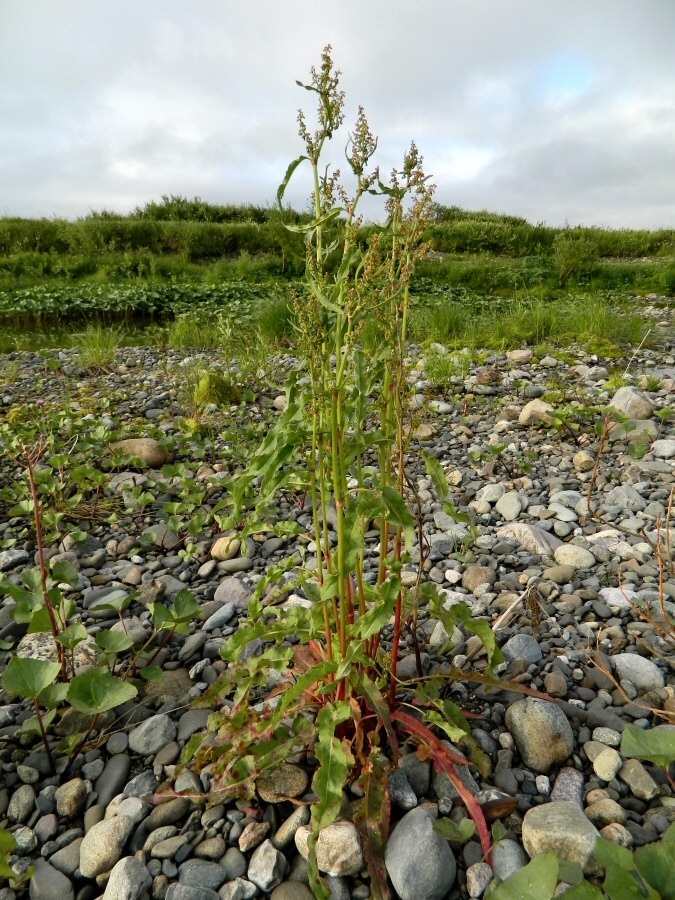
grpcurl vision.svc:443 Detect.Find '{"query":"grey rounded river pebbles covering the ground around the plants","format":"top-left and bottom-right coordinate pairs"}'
top-left (0, 304), bottom-right (675, 900)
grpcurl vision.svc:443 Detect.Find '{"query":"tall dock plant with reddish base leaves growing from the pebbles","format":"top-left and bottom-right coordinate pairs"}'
top-left (184, 47), bottom-right (498, 897)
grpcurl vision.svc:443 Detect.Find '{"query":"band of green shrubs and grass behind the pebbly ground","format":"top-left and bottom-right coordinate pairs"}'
top-left (0, 150), bottom-right (675, 352)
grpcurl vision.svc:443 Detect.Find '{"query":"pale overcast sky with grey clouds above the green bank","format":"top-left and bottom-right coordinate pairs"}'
top-left (0, 0), bottom-right (675, 228)
